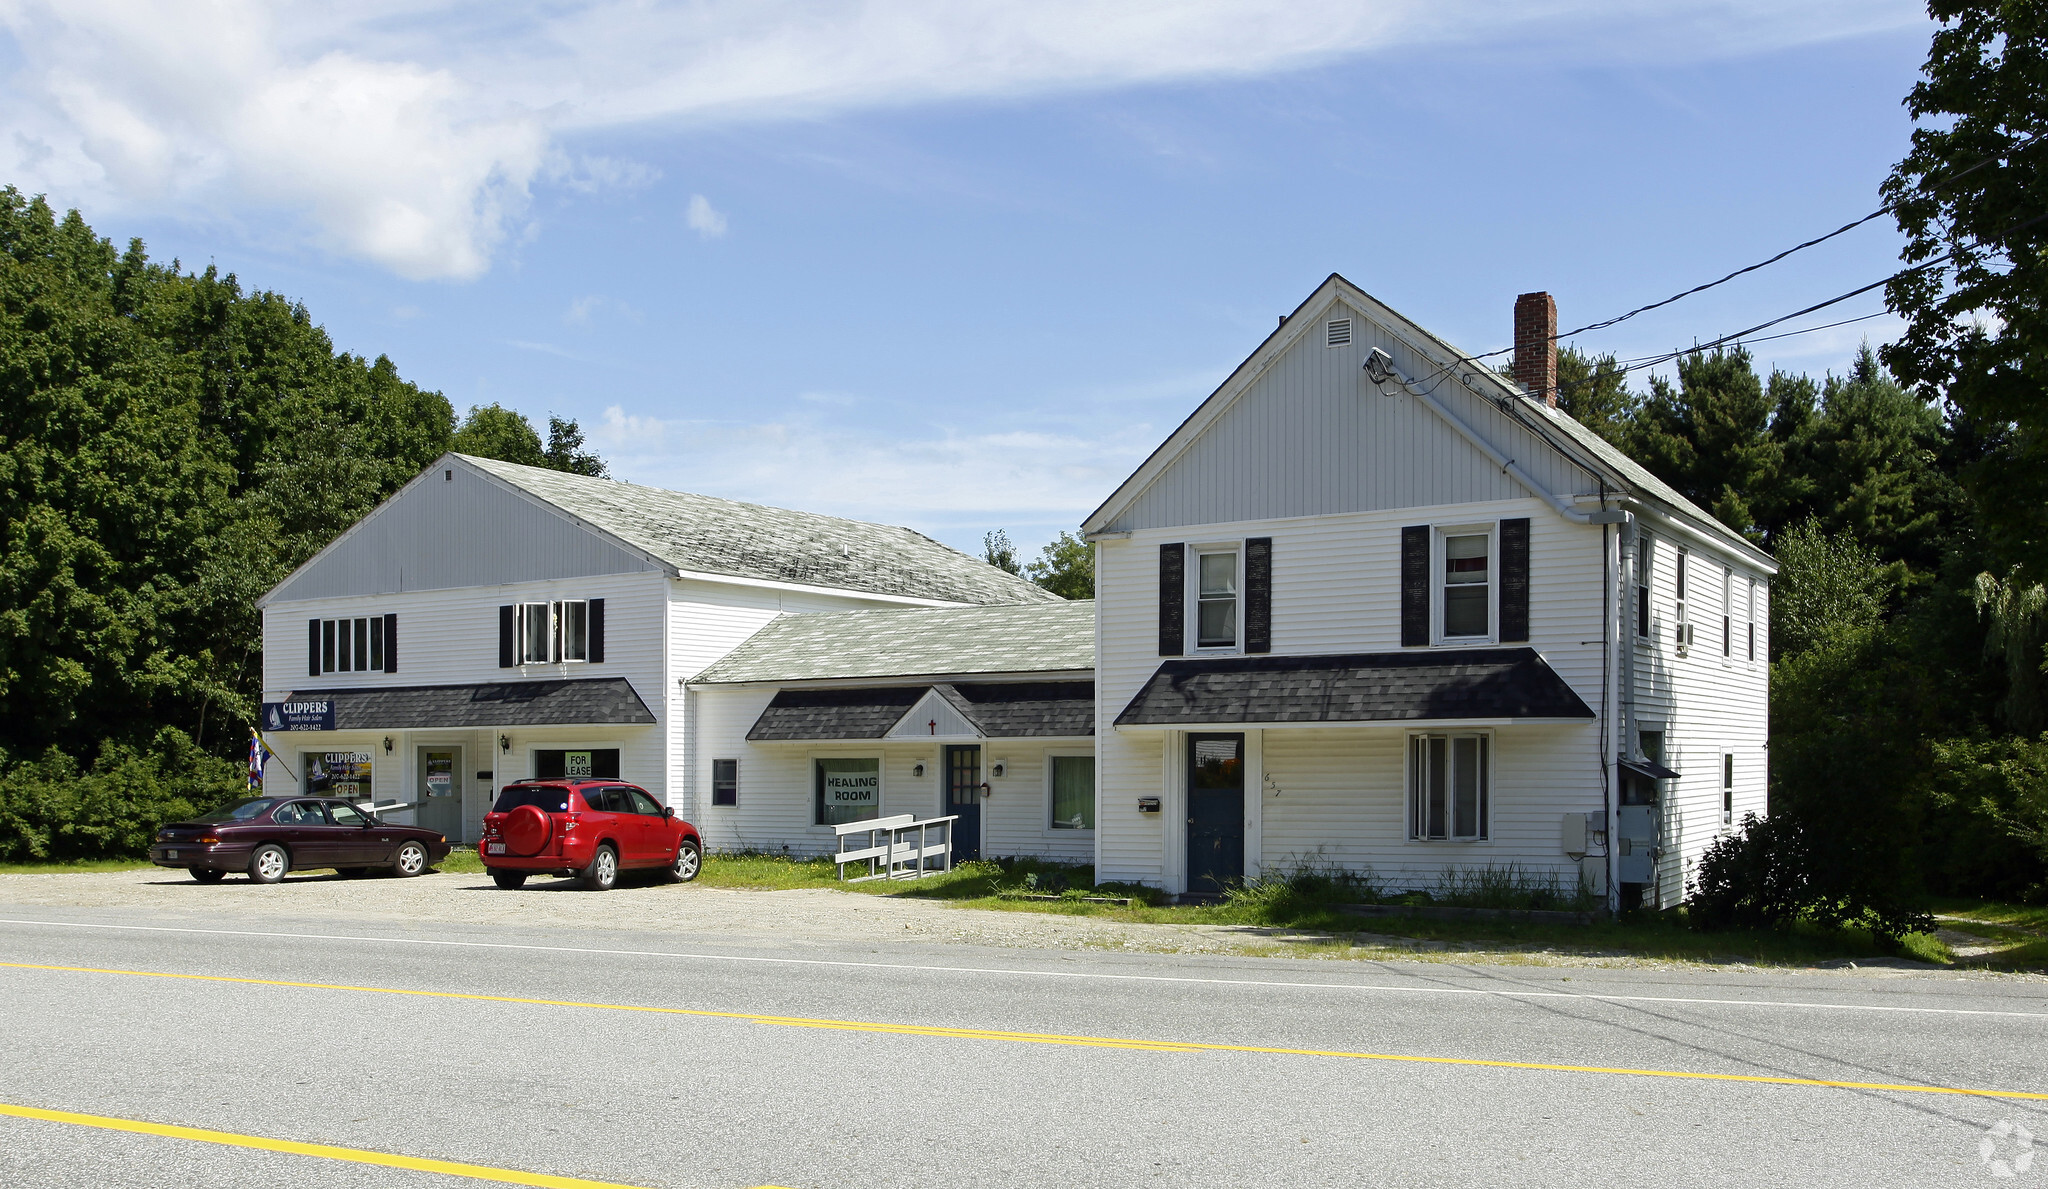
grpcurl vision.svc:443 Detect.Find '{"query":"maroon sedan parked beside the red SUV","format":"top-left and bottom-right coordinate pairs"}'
top-left (150, 796), bottom-right (449, 884)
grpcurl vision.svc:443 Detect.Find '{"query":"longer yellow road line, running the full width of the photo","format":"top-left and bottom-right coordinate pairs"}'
top-left (0, 962), bottom-right (2048, 1101)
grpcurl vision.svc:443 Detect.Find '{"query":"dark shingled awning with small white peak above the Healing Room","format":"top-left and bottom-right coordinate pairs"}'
top-left (748, 681), bottom-right (1096, 743)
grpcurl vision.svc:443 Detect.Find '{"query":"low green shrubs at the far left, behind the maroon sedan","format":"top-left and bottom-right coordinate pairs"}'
top-left (0, 726), bottom-right (246, 864)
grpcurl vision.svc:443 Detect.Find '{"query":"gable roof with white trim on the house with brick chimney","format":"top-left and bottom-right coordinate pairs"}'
top-left (1081, 272), bottom-right (1774, 569)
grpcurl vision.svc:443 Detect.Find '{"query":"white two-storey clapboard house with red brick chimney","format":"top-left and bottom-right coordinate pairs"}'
top-left (1085, 276), bottom-right (1776, 905)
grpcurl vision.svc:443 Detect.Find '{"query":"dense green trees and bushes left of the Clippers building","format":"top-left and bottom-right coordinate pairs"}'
top-left (0, 186), bottom-right (604, 860)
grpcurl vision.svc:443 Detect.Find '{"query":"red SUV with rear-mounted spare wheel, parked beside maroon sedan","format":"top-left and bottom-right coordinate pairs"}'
top-left (477, 780), bottom-right (705, 892)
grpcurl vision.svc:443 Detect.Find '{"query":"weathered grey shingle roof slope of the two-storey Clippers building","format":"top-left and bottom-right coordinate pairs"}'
top-left (461, 454), bottom-right (1059, 604)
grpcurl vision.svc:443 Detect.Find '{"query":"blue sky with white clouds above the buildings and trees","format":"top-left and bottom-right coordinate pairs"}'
top-left (0, 0), bottom-right (1931, 553)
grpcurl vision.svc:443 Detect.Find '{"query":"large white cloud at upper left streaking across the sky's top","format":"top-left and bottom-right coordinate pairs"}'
top-left (0, 0), bottom-right (1925, 278)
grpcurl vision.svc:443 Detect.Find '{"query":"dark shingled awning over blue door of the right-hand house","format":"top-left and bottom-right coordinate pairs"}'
top-left (1116, 649), bottom-right (1593, 726)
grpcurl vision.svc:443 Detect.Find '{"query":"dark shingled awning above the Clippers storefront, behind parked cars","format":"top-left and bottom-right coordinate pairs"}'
top-left (272, 677), bottom-right (653, 731)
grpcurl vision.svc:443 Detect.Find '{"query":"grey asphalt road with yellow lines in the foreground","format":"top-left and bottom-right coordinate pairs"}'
top-left (0, 896), bottom-right (2048, 1189)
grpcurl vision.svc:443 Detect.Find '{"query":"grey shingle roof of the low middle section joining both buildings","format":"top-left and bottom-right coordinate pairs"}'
top-left (690, 600), bottom-right (1096, 686)
